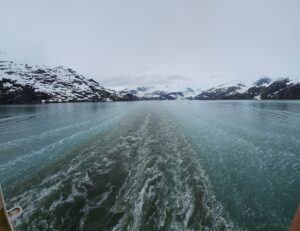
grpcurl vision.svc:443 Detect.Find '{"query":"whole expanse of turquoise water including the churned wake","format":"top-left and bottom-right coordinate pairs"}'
top-left (0, 101), bottom-right (300, 230)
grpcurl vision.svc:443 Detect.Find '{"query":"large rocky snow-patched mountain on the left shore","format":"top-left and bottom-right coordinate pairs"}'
top-left (0, 61), bottom-right (134, 103)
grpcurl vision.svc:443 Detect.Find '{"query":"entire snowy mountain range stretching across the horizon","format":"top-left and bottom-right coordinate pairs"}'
top-left (0, 61), bottom-right (300, 103)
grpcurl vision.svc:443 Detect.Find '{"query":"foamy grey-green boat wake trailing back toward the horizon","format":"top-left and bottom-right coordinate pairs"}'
top-left (7, 105), bottom-right (238, 230)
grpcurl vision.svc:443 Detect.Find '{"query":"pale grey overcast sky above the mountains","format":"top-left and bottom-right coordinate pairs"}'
top-left (0, 0), bottom-right (300, 88)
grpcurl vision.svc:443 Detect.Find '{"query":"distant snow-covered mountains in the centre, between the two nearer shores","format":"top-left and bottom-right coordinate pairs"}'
top-left (120, 85), bottom-right (201, 100)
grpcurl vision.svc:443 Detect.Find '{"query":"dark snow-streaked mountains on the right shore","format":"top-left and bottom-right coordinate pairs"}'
top-left (194, 78), bottom-right (300, 100)
